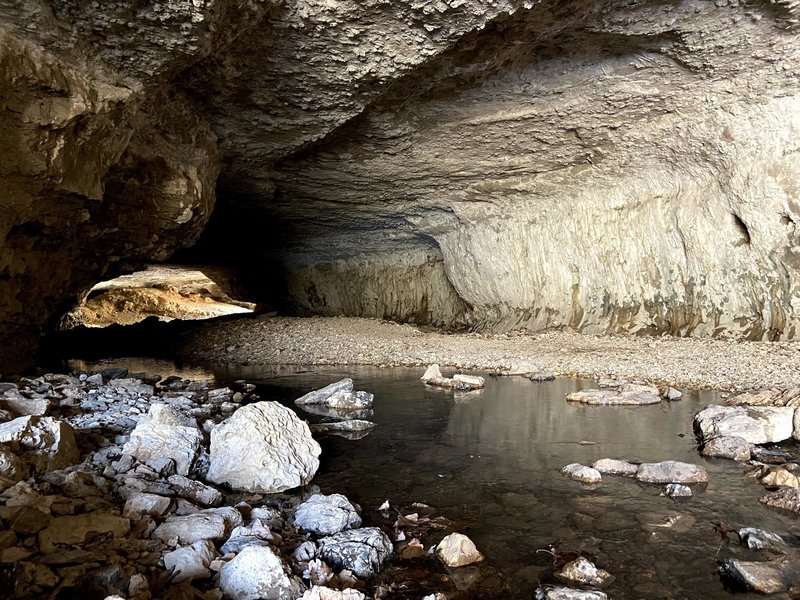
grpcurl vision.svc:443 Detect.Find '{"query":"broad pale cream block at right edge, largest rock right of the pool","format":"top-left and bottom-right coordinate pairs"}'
top-left (694, 404), bottom-right (794, 444)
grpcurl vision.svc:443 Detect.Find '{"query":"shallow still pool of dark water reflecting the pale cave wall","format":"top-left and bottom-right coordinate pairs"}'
top-left (72, 358), bottom-right (800, 599)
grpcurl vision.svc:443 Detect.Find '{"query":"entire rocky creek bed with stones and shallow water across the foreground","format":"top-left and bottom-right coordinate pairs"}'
top-left (0, 350), bottom-right (800, 600)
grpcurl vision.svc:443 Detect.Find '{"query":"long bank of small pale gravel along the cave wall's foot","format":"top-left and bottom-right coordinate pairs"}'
top-left (181, 316), bottom-right (800, 390)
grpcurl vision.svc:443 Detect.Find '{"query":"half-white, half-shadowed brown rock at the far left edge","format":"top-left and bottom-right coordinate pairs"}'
top-left (0, 416), bottom-right (80, 473)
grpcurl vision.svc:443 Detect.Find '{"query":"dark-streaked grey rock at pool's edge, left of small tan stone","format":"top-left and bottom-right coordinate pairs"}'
top-left (319, 527), bottom-right (392, 579)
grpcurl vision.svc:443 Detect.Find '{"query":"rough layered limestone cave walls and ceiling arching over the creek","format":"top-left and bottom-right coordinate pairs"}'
top-left (0, 0), bottom-right (800, 371)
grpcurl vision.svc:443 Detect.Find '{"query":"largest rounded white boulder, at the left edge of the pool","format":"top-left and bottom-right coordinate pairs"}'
top-left (206, 402), bottom-right (322, 494)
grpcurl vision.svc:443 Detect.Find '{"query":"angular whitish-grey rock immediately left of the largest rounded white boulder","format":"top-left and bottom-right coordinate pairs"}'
top-left (123, 404), bottom-right (203, 475)
